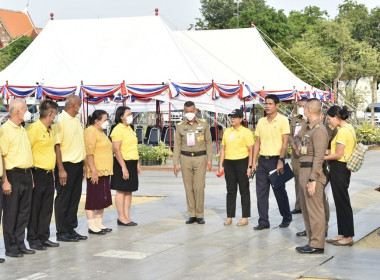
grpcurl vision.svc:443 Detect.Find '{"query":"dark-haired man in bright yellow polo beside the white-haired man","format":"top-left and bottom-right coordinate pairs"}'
top-left (26, 100), bottom-right (59, 250)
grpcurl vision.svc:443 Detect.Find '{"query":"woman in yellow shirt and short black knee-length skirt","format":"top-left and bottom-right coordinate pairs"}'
top-left (111, 106), bottom-right (141, 226)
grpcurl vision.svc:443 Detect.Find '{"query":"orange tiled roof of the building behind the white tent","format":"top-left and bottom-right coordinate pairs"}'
top-left (0, 9), bottom-right (37, 38)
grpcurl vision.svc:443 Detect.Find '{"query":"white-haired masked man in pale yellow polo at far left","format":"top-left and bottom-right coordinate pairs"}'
top-left (0, 99), bottom-right (35, 258)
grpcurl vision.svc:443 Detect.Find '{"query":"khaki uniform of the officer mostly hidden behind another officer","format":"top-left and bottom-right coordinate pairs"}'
top-left (289, 115), bottom-right (306, 209)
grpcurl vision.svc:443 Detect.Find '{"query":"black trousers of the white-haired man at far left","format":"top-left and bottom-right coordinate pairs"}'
top-left (3, 170), bottom-right (33, 253)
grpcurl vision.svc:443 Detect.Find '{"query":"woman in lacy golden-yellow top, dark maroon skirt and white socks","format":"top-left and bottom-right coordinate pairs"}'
top-left (84, 110), bottom-right (113, 234)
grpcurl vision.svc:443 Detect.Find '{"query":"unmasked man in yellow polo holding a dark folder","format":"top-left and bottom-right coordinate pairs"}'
top-left (252, 94), bottom-right (292, 230)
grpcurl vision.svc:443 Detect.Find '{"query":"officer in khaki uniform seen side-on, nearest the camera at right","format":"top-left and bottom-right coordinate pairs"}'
top-left (296, 98), bottom-right (328, 254)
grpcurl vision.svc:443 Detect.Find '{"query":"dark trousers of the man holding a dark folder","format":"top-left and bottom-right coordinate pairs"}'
top-left (256, 157), bottom-right (292, 226)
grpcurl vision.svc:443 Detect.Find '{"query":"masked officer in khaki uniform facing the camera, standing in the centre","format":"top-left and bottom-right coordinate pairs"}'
top-left (174, 101), bottom-right (212, 224)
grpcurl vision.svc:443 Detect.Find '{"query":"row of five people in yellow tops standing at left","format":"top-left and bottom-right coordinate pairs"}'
top-left (0, 95), bottom-right (140, 263)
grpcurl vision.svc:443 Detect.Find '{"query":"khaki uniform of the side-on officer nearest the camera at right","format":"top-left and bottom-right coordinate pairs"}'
top-left (299, 120), bottom-right (328, 248)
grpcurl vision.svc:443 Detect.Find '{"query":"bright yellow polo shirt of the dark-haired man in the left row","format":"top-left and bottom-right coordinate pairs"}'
top-left (26, 120), bottom-right (56, 170)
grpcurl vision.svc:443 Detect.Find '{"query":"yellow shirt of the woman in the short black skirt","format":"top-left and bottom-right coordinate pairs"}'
top-left (111, 123), bottom-right (139, 160)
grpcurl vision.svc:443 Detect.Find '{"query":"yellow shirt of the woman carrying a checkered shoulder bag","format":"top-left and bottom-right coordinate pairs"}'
top-left (331, 124), bottom-right (355, 162)
